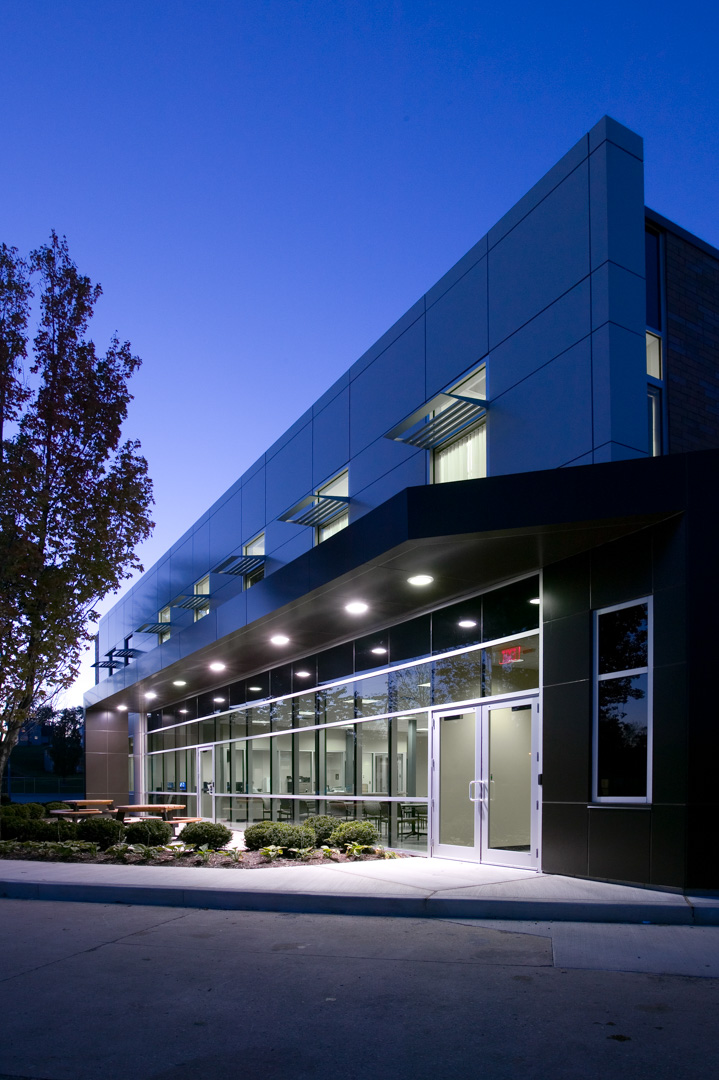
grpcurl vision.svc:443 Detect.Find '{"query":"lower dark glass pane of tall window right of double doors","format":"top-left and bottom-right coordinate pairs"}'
top-left (597, 675), bottom-right (648, 798)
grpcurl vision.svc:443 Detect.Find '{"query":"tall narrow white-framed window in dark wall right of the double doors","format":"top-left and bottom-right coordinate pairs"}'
top-left (593, 597), bottom-right (652, 802)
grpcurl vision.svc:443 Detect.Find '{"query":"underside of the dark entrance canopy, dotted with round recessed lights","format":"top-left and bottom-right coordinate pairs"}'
top-left (94, 513), bottom-right (671, 711)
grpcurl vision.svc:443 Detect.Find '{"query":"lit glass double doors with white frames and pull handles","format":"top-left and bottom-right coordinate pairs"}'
top-left (431, 697), bottom-right (540, 867)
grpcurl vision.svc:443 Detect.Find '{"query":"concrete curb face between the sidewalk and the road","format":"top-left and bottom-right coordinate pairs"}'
top-left (0, 880), bottom-right (719, 927)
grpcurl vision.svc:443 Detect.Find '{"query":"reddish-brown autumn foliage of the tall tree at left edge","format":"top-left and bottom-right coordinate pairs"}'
top-left (0, 232), bottom-right (152, 775)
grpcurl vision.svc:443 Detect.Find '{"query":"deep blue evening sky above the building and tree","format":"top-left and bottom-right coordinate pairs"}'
top-left (0, 0), bottom-right (719, 704)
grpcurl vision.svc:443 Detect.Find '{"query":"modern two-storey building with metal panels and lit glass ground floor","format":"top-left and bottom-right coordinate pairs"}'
top-left (85, 118), bottom-right (719, 889)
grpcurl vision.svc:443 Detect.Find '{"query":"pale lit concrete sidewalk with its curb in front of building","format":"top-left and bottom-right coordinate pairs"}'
top-left (0, 858), bottom-right (719, 926)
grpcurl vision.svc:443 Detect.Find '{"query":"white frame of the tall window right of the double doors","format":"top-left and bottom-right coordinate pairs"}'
top-left (592, 596), bottom-right (654, 806)
